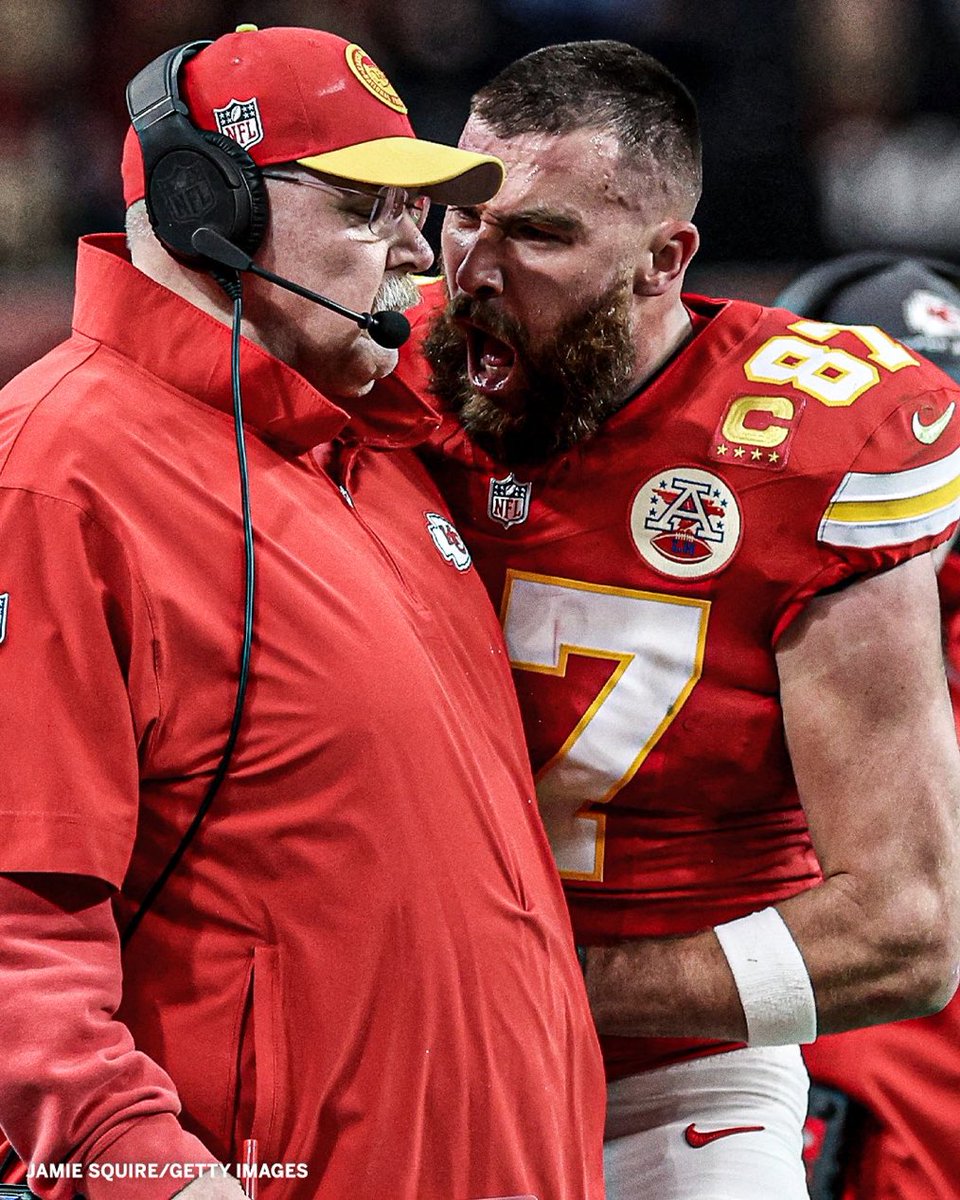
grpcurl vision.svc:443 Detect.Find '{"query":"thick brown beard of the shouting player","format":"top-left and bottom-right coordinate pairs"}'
top-left (424, 281), bottom-right (636, 466)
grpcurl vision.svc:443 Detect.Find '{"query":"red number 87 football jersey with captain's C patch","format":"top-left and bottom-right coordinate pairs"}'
top-left (402, 286), bottom-right (960, 1075)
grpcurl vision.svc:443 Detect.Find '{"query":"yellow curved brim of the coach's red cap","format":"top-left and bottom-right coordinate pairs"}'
top-left (296, 138), bottom-right (504, 204)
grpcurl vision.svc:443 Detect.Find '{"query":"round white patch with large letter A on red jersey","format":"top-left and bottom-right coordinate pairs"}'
top-left (630, 467), bottom-right (740, 580)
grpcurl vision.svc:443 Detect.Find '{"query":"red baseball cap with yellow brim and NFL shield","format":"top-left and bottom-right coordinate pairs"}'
top-left (121, 25), bottom-right (504, 205)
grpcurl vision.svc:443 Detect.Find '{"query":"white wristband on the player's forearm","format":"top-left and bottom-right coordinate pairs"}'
top-left (713, 908), bottom-right (817, 1046)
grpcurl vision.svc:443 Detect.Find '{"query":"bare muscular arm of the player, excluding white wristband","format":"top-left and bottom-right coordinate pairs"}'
top-left (587, 556), bottom-right (960, 1039)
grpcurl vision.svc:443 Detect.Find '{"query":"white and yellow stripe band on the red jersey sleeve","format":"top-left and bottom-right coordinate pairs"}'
top-left (817, 450), bottom-right (960, 550)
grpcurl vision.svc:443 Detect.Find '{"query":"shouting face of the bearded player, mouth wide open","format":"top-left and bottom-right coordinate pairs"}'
top-left (426, 118), bottom-right (653, 462)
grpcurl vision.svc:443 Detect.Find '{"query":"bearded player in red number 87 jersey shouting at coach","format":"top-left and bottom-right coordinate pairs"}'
top-left (393, 42), bottom-right (960, 1200)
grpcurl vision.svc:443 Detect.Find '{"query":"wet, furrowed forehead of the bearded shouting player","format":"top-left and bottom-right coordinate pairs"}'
top-left (460, 118), bottom-right (637, 215)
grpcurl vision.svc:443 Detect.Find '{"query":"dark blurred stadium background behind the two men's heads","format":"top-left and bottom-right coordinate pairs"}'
top-left (0, 0), bottom-right (960, 382)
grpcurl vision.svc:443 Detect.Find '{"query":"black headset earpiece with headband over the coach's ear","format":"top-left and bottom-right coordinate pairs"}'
top-left (127, 42), bottom-right (270, 265)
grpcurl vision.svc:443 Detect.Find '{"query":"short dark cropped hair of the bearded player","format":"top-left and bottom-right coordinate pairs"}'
top-left (470, 40), bottom-right (702, 213)
